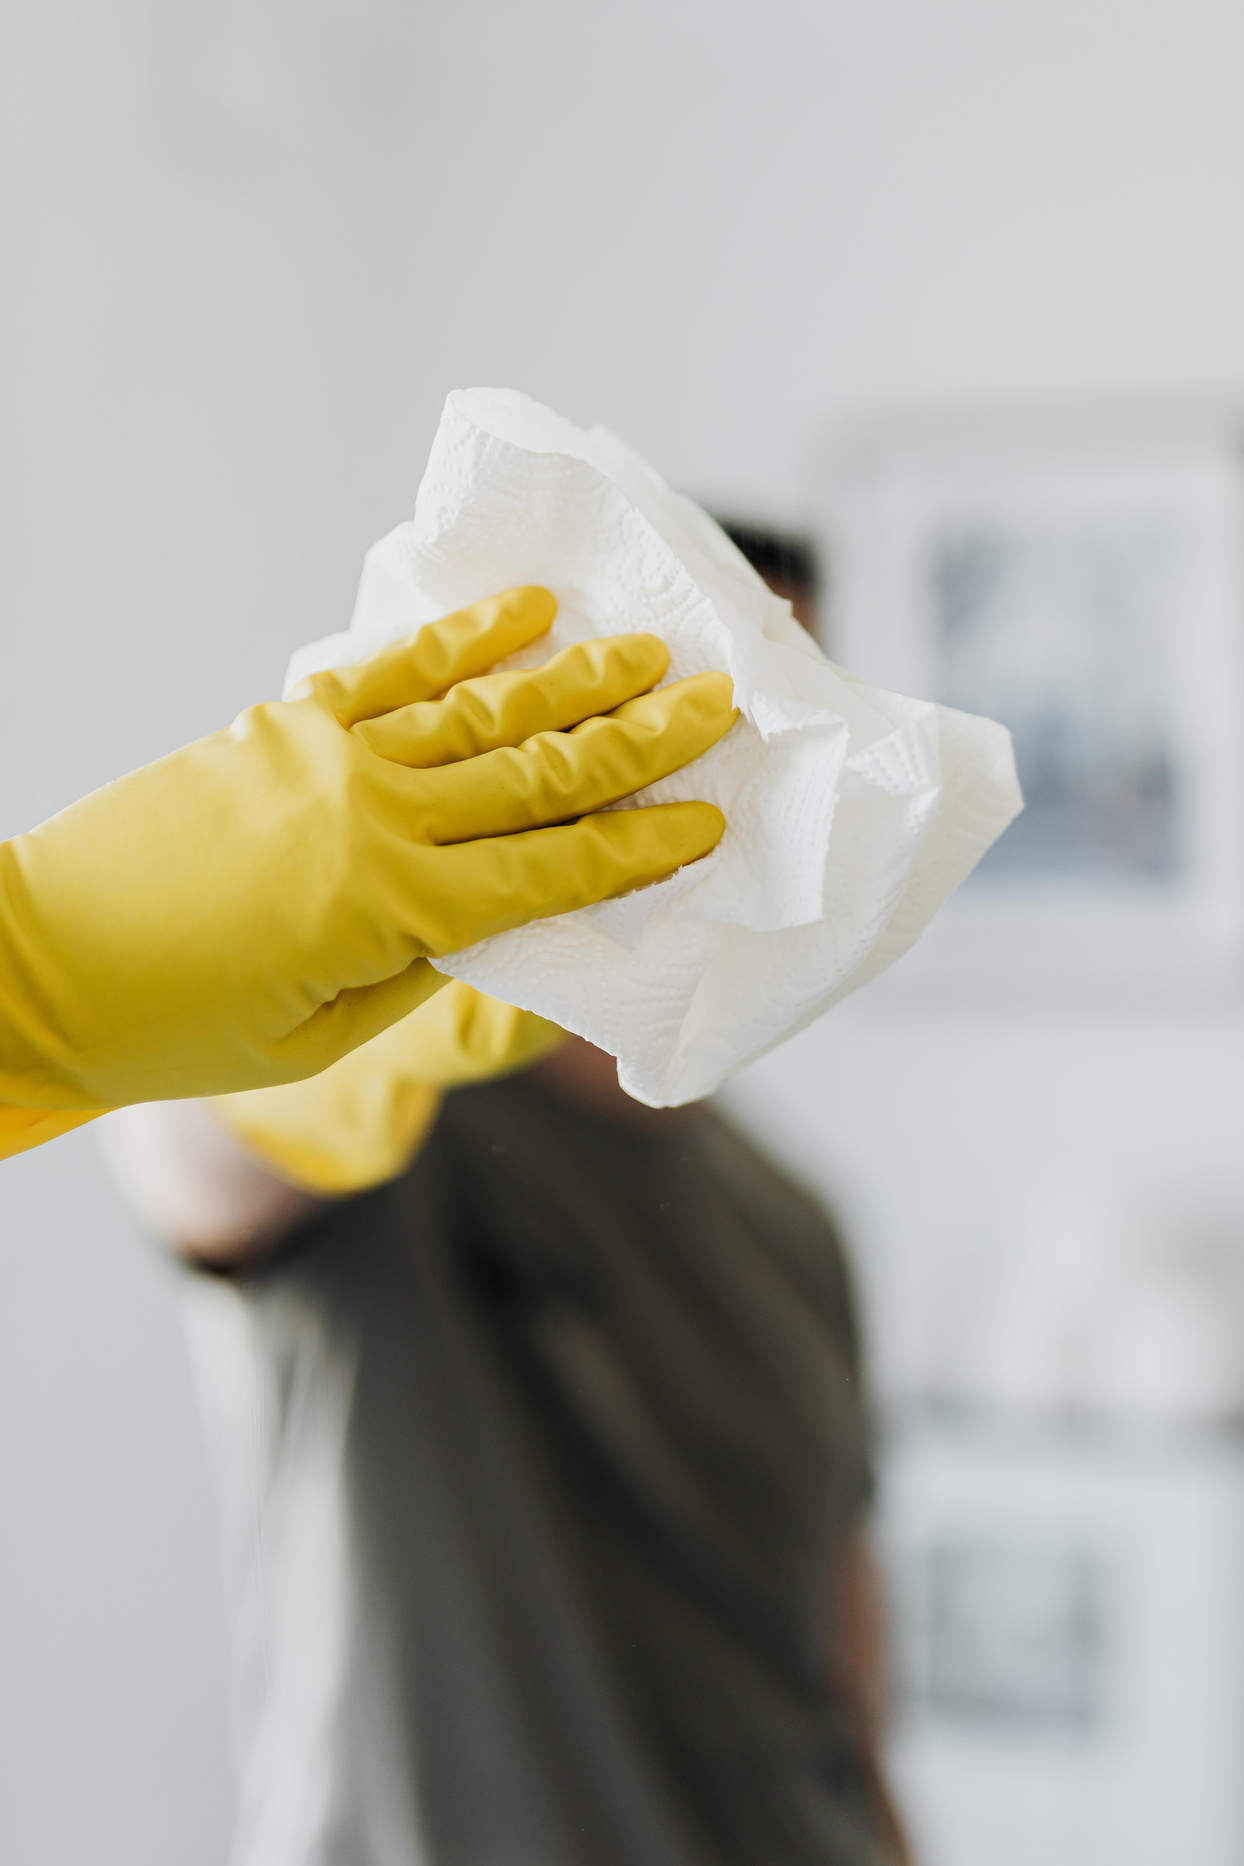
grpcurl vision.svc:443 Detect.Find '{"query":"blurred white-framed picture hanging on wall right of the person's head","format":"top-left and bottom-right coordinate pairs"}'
top-left (819, 405), bottom-right (1244, 991)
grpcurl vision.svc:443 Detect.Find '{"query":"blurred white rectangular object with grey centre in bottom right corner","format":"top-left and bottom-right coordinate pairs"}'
top-left (882, 1414), bottom-right (1244, 1866)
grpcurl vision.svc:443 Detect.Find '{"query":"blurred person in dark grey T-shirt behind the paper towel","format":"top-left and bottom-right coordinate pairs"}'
top-left (108, 526), bottom-right (905, 1866)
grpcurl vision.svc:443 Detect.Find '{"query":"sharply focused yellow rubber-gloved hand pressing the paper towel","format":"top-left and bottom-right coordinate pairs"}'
top-left (0, 590), bottom-right (735, 1146)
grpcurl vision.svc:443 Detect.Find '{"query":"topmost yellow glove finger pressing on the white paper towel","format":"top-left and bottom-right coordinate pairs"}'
top-left (291, 584), bottom-right (558, 726)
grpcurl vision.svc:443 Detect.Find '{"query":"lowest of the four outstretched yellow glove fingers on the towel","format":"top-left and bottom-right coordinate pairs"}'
top-left (404, 802), bottom-right (726, 955)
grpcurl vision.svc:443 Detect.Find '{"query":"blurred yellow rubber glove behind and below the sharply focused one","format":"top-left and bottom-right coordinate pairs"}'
top-left (209, 980), bottom-right (565, 1198)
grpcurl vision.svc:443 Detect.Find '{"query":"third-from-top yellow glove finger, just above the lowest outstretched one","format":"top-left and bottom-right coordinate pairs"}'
top-left (408, 674), bottom-right (737, 843)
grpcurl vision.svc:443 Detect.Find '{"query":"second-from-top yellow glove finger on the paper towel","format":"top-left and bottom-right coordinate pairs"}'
top-left (354, 634), bottom-right (670, 771)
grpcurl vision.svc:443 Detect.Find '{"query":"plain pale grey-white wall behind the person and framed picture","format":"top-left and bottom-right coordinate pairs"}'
top-left (0, 0), bottom-right (1244, 1866)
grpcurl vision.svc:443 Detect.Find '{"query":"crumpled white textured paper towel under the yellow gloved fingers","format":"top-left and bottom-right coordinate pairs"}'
top-left (285, 388), bottom-right (1022, 1107)
